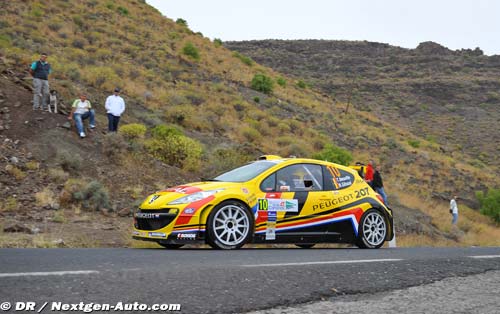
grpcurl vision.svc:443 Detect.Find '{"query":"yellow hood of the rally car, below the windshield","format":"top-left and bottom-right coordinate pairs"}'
top-left (140, 182), bottom-right (244, 209)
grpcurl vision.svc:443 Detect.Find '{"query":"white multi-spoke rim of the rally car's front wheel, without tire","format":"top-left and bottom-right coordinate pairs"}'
top-left (213, 205), bottom-right (250, 245)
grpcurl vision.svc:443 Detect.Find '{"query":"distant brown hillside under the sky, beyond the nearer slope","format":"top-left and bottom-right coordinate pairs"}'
top-left (224, 40), bottom-right (500, 169)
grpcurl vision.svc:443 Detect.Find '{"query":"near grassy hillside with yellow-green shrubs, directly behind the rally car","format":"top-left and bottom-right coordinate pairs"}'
top-left (0, 0), bottom-right (500, 246)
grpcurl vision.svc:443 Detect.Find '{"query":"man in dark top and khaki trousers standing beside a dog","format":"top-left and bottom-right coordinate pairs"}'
top-left (30, 53), bottom-right (52, 110)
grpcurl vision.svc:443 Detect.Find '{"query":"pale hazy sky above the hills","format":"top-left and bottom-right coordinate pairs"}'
top-left (147, 0), bottom-right (500, 55)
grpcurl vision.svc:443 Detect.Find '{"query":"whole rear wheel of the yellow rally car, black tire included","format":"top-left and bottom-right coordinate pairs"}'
top-left (356, 209), bottom-right (388, 249)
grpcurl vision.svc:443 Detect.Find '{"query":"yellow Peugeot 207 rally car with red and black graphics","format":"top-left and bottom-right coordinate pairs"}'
top-left (133, 156), bottom-right (393, 249)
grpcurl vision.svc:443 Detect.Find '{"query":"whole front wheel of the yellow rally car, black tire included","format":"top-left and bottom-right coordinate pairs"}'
top-left (207, 201), bottom-right (254, 250)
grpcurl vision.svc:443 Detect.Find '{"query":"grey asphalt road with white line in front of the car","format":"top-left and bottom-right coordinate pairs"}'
top-left (0, 248), bottom-right (500, 313)
